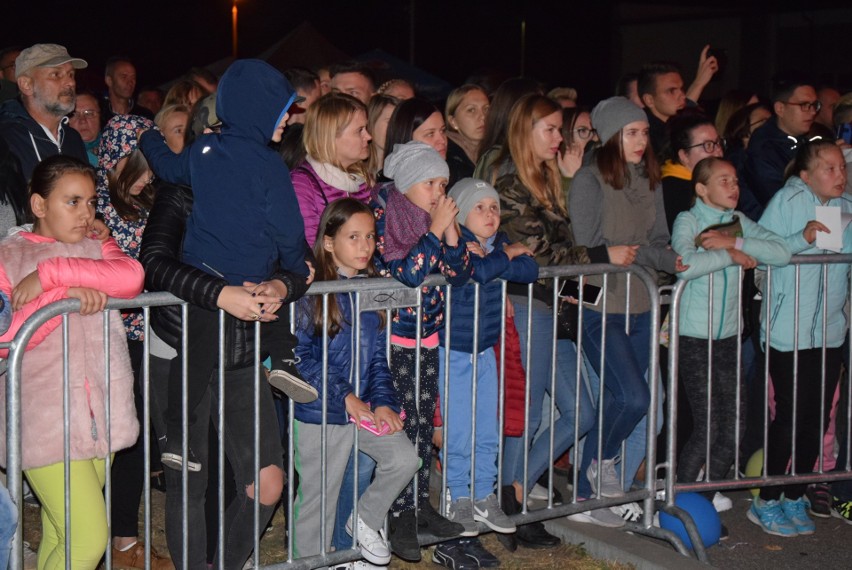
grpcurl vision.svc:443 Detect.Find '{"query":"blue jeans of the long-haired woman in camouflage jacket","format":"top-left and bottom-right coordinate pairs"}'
top-left (503, 296), bottom-right (594, 491)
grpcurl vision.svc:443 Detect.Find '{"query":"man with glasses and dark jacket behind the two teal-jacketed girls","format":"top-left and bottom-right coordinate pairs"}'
top-left (739, 75), bottom-right (821, 220)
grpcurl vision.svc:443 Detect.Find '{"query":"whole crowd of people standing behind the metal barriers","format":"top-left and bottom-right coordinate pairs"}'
top-left (0, 40), bottom-right (852, 570)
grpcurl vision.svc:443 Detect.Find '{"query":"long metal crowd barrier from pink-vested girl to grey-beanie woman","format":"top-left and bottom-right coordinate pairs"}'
top-left (0, 264), bottom-right (680, 570)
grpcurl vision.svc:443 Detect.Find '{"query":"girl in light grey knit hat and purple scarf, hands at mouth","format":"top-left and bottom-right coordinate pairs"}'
top-left (371, 140), bottom-right (471, 561)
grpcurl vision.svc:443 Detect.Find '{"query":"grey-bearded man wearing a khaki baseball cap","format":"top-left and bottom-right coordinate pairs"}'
top-left (0, 44), bottom-right (88, 182)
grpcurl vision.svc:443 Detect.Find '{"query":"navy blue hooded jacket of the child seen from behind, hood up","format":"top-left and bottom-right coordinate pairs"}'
top-left (141, 59), bottom-right (308, 285)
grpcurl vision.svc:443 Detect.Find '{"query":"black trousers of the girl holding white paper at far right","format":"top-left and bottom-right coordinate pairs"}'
top-left (760, 348), bottom-right (843, 500)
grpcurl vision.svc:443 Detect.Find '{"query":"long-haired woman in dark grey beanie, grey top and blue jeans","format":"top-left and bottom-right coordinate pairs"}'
top-left (569, 97), bottom-right (683, 524)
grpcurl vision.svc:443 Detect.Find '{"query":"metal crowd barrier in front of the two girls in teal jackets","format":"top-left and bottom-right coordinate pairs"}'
top-left (658, 254), bottom-right (852, 562)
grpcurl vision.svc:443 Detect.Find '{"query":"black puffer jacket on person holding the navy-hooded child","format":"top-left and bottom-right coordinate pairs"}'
top-left (139, 181), bottom-right (308, 370)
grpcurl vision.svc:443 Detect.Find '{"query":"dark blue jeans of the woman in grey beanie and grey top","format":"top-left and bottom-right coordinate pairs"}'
top-left (577, 311), bottom-right (651, 498)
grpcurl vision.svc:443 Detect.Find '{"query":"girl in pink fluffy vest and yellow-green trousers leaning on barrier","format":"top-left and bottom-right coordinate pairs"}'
top-left (0, 155), bottom-right (144, 568)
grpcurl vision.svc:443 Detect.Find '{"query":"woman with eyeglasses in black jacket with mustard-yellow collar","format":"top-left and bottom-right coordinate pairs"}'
top-left (662, 113), bottom-right (725, 233)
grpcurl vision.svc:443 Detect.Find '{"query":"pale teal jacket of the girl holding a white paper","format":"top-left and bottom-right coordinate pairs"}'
top-left (760, 176), bottom-right (852, 352)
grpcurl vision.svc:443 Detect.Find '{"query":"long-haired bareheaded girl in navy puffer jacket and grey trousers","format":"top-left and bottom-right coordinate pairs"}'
top-left (293, 198), bottom-right (417, 564)
